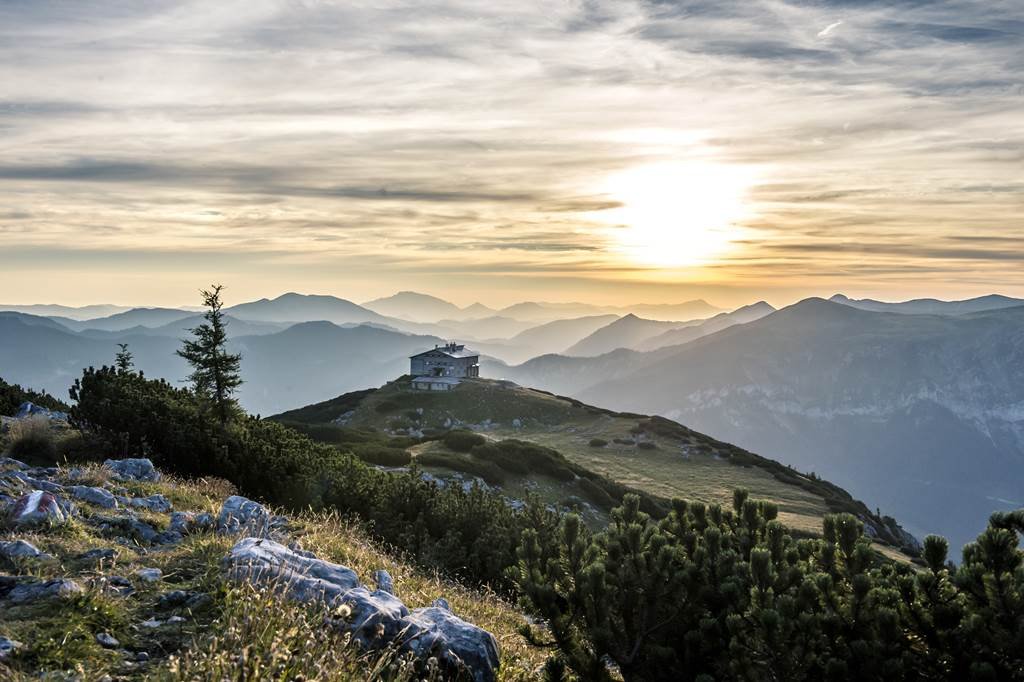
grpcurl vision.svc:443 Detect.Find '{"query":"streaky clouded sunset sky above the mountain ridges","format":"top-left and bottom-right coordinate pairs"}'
top-left (0, 0), bottom-right (1024, 306)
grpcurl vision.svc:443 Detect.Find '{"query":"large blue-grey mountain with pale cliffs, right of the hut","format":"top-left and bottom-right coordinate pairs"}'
top-left (482, 299), bottom-right (1024, 543)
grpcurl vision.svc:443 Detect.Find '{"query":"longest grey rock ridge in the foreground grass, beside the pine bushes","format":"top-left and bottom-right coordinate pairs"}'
top-left (225, 538), bottom-right (499, 682)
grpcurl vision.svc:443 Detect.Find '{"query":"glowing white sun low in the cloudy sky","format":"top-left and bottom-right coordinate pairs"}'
top-left (601, 162), bottom-right (755, 267)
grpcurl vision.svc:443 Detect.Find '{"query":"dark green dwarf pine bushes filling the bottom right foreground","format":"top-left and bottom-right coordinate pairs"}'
top-left (515, 491), bottom-right (1024, 682)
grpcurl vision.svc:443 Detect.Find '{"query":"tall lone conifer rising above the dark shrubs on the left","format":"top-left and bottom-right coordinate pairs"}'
top-left (178, 285), bottom-right (242, 425)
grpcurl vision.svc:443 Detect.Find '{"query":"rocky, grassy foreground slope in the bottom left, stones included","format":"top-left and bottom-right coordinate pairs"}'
top-left (0, 459), bottom-right (544, 682)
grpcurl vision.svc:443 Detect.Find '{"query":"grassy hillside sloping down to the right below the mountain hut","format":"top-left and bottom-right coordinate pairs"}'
top-left (271, 379), bottom-right (921, 552)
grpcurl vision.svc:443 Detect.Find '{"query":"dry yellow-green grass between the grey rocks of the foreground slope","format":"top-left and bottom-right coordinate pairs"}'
top-left (0, 458), bottom-right (546, 680)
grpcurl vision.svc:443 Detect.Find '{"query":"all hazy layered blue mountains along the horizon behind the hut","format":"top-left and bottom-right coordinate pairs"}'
top-left (0, 292), bottom-right (1024, 543)
